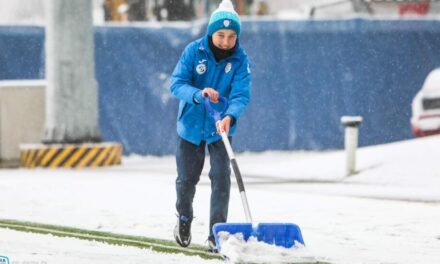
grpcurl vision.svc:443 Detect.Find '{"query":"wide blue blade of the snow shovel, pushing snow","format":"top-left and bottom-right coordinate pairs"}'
top-left (212, 223), bottom-right (304, 251)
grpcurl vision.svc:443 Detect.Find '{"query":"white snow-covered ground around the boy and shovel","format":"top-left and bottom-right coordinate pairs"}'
top-left (0, 136), bottom-right (440, 263)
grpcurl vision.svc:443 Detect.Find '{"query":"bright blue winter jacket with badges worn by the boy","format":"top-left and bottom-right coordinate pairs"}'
top-left (170, 36), bottom-right (251, 145)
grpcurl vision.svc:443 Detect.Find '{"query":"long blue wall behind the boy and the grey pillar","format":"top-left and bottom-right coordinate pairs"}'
top-left (0, 19), bottom-right (440, 154)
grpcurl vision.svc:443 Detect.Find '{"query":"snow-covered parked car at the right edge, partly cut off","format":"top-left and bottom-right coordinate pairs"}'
top-left (411, 68), bottom-right (440, 137)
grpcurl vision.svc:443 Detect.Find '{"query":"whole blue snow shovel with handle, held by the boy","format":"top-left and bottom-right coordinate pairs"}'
top-left (205, 97), bottom-right (304, 252)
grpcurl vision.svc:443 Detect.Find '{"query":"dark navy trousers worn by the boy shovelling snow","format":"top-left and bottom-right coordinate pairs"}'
top-left (176, 137), bottom-right (231, 236)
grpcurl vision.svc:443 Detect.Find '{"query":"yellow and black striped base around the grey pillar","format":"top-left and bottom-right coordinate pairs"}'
top-left (20, 142), bottom-right (122, 169)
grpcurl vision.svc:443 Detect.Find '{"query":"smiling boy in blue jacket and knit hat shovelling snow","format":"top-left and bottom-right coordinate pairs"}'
top-left (170, 0), bottom-right (251, 251)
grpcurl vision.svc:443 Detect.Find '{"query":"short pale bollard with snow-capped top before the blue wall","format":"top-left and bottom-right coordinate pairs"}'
top-left (341, 116), bottom-right (363, 176)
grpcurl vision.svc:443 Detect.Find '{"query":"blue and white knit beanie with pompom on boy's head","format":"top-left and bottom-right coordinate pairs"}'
top-left (208, 0), bottom-right (241, 37)
